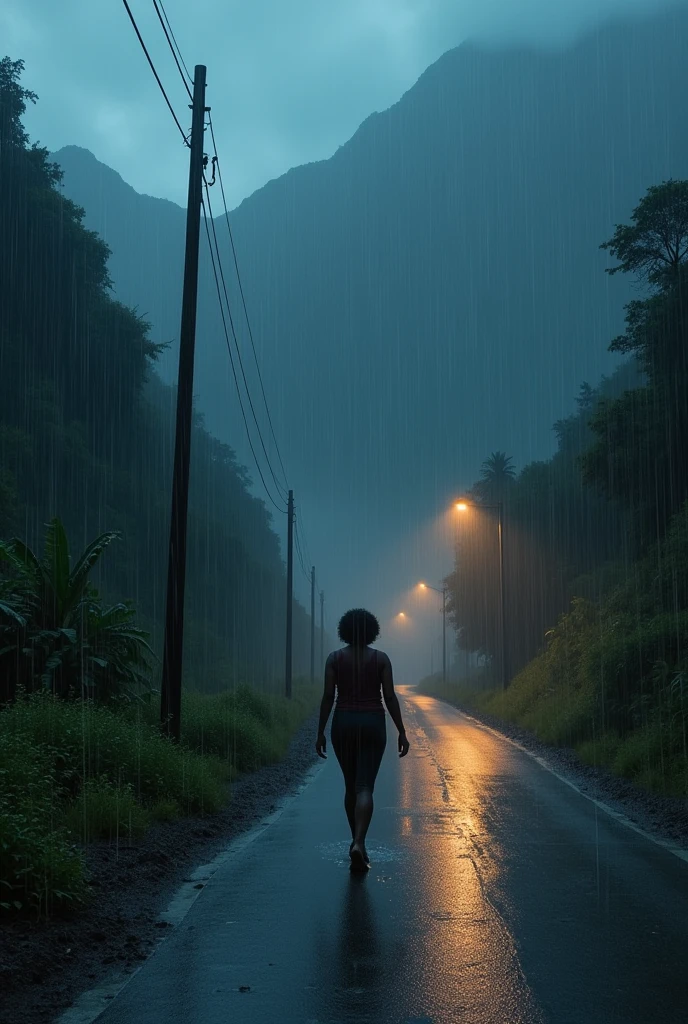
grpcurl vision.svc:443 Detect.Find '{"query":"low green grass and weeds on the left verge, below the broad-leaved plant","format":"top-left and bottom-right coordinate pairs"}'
top-left (0, 684), bottom-right (316, 911)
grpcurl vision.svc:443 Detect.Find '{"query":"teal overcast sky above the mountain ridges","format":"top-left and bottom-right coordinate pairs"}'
top-left (0, 0), bottom-right (678, 206)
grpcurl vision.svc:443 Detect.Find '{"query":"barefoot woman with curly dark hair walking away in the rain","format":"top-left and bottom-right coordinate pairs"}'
top-left (315, 608), bottom-right (409, 870)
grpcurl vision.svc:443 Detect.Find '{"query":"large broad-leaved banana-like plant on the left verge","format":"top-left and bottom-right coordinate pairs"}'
top-left (0, 519), bottom-right (153, 699)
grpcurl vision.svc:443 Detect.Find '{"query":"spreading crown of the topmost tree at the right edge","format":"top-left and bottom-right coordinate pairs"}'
top-left (600, 178), bottom-right (688, 288)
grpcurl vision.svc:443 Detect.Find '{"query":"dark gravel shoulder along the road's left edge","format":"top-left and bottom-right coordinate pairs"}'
top-left (0, 714), bottom-right (317, 1024)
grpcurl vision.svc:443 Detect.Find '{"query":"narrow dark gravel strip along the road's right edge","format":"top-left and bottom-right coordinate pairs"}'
top-left (436, 701), bottom-right (688, 851)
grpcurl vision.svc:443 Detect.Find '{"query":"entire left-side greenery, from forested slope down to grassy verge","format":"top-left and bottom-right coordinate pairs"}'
top-left (0, 57), bottom-right (323, 913)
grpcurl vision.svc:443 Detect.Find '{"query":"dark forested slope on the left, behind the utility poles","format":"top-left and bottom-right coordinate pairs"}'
top-left (0, 57), bottom-right (315, 689)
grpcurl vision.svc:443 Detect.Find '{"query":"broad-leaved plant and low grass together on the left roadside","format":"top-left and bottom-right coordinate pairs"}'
top-left (0, 519), bottom-right (317, 912)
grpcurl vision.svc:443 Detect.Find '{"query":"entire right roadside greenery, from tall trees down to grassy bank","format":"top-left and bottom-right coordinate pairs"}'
top-left (436, 180), bottom-right (688, 798)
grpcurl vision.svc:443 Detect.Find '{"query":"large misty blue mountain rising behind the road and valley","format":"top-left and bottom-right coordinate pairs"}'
top-left (55, 7), bottom-right (688, 626)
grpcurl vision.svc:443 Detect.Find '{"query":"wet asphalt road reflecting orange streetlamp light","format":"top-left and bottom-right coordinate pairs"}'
top-left (88, 687), bottom-right (688, 1024)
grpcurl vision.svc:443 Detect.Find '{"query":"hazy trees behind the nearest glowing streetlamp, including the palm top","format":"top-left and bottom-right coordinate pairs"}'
top-left (447, 362), bottom-right (640, 675)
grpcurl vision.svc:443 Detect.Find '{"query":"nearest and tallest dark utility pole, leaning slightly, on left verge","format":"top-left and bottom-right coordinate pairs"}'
top-left (160, 65), bottom-right (206, 742)
